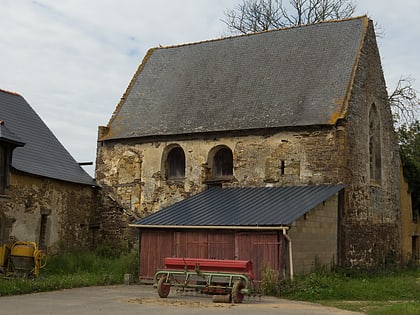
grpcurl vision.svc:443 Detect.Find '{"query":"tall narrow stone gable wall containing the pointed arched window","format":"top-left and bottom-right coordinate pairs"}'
top-left (341, 19), bottom-right (401, 266)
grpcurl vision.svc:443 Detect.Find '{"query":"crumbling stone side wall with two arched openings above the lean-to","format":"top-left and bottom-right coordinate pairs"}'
top-left (96, 129), bottom-right (344, 221)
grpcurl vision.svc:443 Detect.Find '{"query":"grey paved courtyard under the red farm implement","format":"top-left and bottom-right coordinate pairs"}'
top-left (0, 285), bottom-right (360, 315)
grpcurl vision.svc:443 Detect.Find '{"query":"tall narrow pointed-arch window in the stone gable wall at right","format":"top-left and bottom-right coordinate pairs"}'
top-left (369, 104), bottom-right (382, 184)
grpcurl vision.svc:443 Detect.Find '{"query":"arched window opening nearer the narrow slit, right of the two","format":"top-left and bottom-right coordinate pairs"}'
top-left (208, 146), bottom-right (233, 179)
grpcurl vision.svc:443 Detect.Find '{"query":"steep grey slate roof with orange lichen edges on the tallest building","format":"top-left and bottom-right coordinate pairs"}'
top-left (101, 17), bottom-right (369, 140)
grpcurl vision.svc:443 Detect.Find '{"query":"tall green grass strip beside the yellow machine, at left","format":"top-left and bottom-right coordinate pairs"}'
top-left (0, 251), bottom-right (138, 295)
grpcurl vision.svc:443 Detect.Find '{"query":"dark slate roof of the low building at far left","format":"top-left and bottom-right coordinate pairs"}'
top-left (0, 90), bottom-right (96, 185)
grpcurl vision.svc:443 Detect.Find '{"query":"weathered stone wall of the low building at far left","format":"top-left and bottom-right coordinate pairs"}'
top-left (0, 172), bottom-right (98, 251)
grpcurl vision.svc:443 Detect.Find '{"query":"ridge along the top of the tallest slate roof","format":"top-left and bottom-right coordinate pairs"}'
top-left (154, 14), bottom-right (368, 49)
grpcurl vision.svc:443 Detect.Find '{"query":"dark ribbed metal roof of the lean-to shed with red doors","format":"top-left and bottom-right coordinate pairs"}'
top-left (131, 185), bottom-right (344, 228)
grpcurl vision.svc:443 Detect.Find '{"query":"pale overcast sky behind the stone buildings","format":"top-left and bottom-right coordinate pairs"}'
top-left (0, 0), bottom-right (420, 176)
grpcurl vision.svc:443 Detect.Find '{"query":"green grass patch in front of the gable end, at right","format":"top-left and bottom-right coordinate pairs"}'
top-left (280, 269), bottom-right (420, 315)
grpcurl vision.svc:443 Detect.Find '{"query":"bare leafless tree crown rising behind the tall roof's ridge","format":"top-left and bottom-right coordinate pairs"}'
top-left (222, 0), bottom-right (356, 34)
